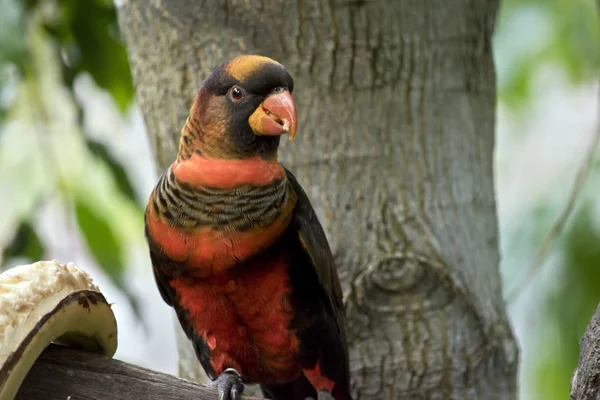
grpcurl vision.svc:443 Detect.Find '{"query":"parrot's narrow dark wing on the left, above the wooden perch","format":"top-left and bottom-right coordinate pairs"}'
top-left (146, 223), bottom-right (214, 379)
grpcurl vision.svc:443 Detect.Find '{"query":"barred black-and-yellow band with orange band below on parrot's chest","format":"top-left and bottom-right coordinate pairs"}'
top-left (146, 159), bottom-right (296, 276)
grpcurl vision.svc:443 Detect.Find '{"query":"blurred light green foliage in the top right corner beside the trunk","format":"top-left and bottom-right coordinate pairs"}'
top-left (494, 0), bottom-right (600, 109)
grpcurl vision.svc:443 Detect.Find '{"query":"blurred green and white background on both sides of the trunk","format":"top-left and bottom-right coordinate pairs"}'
top-left (0, 0), bottom-right (600, 400)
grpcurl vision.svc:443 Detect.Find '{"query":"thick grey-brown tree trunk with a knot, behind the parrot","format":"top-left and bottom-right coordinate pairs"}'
top-left (119, 0), bottom-right (518, 399)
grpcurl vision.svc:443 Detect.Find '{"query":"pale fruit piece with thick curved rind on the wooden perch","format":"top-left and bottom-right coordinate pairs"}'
top-left (0, 260), bottom-right (117, 400)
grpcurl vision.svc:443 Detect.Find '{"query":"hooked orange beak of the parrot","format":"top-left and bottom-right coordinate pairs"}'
top-left (248, 90), bottom-right (298, 140)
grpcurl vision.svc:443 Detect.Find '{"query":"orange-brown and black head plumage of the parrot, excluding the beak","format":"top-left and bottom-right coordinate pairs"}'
top-left (179, 55), bottom-right (294, 159)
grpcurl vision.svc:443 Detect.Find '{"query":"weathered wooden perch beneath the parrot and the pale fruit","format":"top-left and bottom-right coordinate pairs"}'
top-left (16, 344), bottom-right (261, 400)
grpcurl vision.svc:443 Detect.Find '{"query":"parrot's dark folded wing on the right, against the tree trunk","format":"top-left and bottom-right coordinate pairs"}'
top-left (285, 169), bottom-right (347, 349)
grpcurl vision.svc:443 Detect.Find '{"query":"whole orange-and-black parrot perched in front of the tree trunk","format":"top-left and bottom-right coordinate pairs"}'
top-left (144, 55), bottom-right (352, 400)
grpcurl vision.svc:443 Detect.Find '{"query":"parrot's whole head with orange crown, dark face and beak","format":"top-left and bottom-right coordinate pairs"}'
top-left (180, 55), bottom-right (297, 159)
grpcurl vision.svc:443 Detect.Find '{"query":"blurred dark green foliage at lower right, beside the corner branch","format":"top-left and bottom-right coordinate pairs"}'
top-left (537, 206), bottom-right (600, 399)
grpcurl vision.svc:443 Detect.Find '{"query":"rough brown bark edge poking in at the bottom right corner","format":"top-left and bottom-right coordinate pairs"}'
top-left (570, 305), bottom-right (600, 400)
